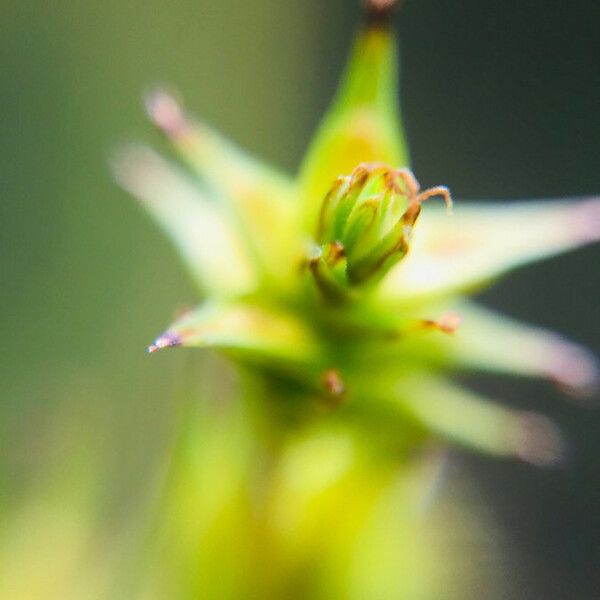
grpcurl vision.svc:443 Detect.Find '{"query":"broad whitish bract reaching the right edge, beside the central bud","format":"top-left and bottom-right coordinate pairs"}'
top-left (380, 198), bottom-right (600, 302)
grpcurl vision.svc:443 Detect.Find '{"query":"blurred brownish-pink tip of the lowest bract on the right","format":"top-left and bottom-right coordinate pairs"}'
top-left (514, 412), bottom-right (566, 467)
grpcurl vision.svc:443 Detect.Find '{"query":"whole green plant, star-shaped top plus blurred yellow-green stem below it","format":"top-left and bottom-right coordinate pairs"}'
top-left (115, 0), bottom-right (600, 600)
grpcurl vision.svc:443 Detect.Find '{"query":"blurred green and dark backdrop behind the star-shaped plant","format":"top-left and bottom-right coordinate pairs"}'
top-left (0, 0), bottom-right (600, 600)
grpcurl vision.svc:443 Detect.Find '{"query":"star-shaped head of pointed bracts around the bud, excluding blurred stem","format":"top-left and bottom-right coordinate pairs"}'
top-left (114, 0), bottom-right (600, 464)
